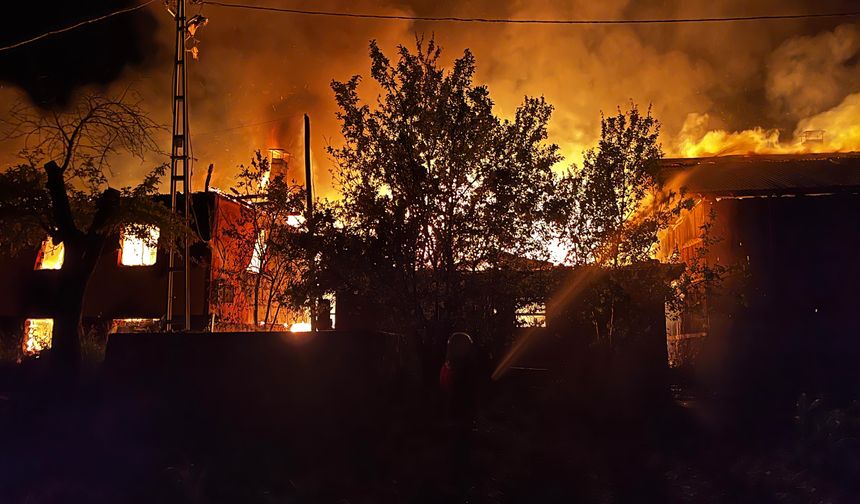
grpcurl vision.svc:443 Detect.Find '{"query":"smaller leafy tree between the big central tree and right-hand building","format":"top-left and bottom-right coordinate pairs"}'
top-left (559, 103), bottom-right (692, 266)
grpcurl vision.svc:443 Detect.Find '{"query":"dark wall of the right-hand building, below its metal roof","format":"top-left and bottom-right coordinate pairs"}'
top-left (661, 194), bottom-right (860, 402)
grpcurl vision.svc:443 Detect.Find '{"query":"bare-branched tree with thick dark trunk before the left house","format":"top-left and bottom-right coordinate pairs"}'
top-left (0, 92), bottom-right (185, 371)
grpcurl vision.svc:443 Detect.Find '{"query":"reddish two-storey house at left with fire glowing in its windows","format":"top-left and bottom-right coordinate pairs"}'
top-left (0, 191), bottom-right (274, 353)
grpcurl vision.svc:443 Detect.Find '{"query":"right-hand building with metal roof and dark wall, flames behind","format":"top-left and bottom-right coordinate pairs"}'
top-left (658, 153), bottom-right (860, 402)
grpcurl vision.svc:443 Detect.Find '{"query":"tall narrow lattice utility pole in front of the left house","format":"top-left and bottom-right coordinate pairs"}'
top-left (164, 0), bottom-right (191, 331)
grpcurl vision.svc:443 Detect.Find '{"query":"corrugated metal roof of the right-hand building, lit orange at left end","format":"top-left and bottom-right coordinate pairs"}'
top-left (661, 152), bottom-right (860, 196)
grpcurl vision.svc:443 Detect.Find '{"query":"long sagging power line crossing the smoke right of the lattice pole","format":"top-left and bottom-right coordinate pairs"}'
top-left (200, 0), bottom-right (860, 25)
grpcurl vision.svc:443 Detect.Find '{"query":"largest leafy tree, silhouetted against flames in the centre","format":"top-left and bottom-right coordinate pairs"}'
top-left (329, 39), bottom-right (560, 334)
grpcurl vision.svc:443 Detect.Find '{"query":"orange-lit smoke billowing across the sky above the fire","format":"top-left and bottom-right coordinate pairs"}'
top-left (0, 0), bottom-right (860, 194)
